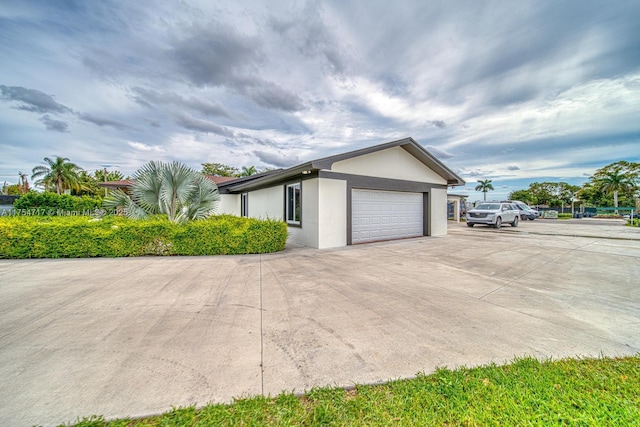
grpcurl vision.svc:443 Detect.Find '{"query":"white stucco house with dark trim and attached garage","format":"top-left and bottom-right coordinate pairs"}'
top-left (218, 138), bottom-right (465, 248)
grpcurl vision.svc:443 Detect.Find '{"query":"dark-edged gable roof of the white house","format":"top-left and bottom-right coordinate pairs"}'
top-left (219, 137), bottom-right (465, 192)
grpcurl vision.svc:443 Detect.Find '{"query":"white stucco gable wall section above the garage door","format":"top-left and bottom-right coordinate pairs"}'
top-left (331, 147), bottom-right (447, 184)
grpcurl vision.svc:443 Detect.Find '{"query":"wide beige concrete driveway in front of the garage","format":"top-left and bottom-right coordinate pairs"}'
top-left (0, 221), bottom-right (640, 426)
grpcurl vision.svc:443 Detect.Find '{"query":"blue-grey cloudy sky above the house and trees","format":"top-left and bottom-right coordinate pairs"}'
top-left (0, 0), bottom-right (640, 200)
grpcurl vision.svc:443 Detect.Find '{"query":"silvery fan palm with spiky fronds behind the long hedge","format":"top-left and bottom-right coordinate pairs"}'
top-left (104, 162), bottom-right (220, 223)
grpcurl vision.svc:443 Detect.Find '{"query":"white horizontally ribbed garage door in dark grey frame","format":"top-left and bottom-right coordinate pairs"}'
top-left (351, 189), bottom-right (423, 244)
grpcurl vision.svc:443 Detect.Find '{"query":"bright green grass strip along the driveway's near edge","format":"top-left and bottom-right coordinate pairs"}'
top-left (61, 354), bottom-right (640, 427)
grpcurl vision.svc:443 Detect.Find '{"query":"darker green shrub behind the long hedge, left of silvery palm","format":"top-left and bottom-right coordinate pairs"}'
top-left (13, 191), bottom-right (102, 216)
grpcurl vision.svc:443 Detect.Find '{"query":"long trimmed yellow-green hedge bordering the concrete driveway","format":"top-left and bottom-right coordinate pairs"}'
top-left (0, 215), bottom-right (287, 259)
